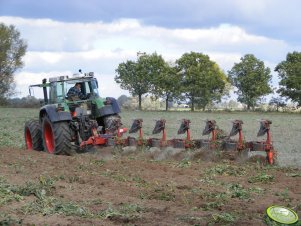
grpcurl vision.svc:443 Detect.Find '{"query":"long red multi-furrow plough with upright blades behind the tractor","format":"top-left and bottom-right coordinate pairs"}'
top-left (98, 119), bottom-right (275, 164)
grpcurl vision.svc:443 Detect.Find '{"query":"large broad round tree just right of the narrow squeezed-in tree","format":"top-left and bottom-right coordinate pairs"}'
top-left (176, 52), bottom-right (227, 111)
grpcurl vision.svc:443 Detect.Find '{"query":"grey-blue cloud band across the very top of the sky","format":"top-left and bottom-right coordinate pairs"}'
top-left (0, 0), bottom-right (301, 43)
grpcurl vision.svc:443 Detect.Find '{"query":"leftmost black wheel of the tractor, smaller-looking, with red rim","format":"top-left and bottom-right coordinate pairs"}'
top-left (24, 119), bottom-right (44, 151)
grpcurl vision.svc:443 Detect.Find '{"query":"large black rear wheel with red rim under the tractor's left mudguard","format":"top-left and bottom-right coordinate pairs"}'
top-left (42, 116), bottom-right (75, 155)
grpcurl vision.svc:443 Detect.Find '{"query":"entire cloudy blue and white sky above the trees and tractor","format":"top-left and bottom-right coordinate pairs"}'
top-left (0, 0), bottom-right (301, 98)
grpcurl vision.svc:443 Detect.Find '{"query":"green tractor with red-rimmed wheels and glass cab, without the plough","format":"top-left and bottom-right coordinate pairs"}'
top-left (24, 71), bottom-right (126, 155)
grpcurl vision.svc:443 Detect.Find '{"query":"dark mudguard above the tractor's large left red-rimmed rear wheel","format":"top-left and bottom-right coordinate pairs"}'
top-left (40, 104), bottom-right (72, 122)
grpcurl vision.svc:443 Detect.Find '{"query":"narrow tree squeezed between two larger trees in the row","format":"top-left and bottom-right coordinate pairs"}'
top-left (151, 63), bottom-right (181, 111)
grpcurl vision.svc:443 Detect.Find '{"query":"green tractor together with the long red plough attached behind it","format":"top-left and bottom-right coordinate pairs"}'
top-left (24, 72), bottom-right (276, 164)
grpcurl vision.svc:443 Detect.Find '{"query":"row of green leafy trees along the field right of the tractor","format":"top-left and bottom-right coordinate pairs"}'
top-left (115, 52), bottom-right (301, 111)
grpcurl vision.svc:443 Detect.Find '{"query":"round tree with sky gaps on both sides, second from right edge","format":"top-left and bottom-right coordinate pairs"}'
top-left (228, 54), bottom-right (272, 110)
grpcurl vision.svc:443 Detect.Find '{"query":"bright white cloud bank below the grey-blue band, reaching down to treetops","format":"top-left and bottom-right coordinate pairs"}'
top-left (0, 15), bottom-right (294, 97)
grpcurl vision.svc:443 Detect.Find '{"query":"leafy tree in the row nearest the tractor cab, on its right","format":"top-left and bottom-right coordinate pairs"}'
top-left (115, 53), bottom-right (165, 110)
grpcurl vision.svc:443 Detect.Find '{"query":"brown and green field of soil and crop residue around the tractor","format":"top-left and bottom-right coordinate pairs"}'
top-left (0, 108), bottom-right (301, 225)
